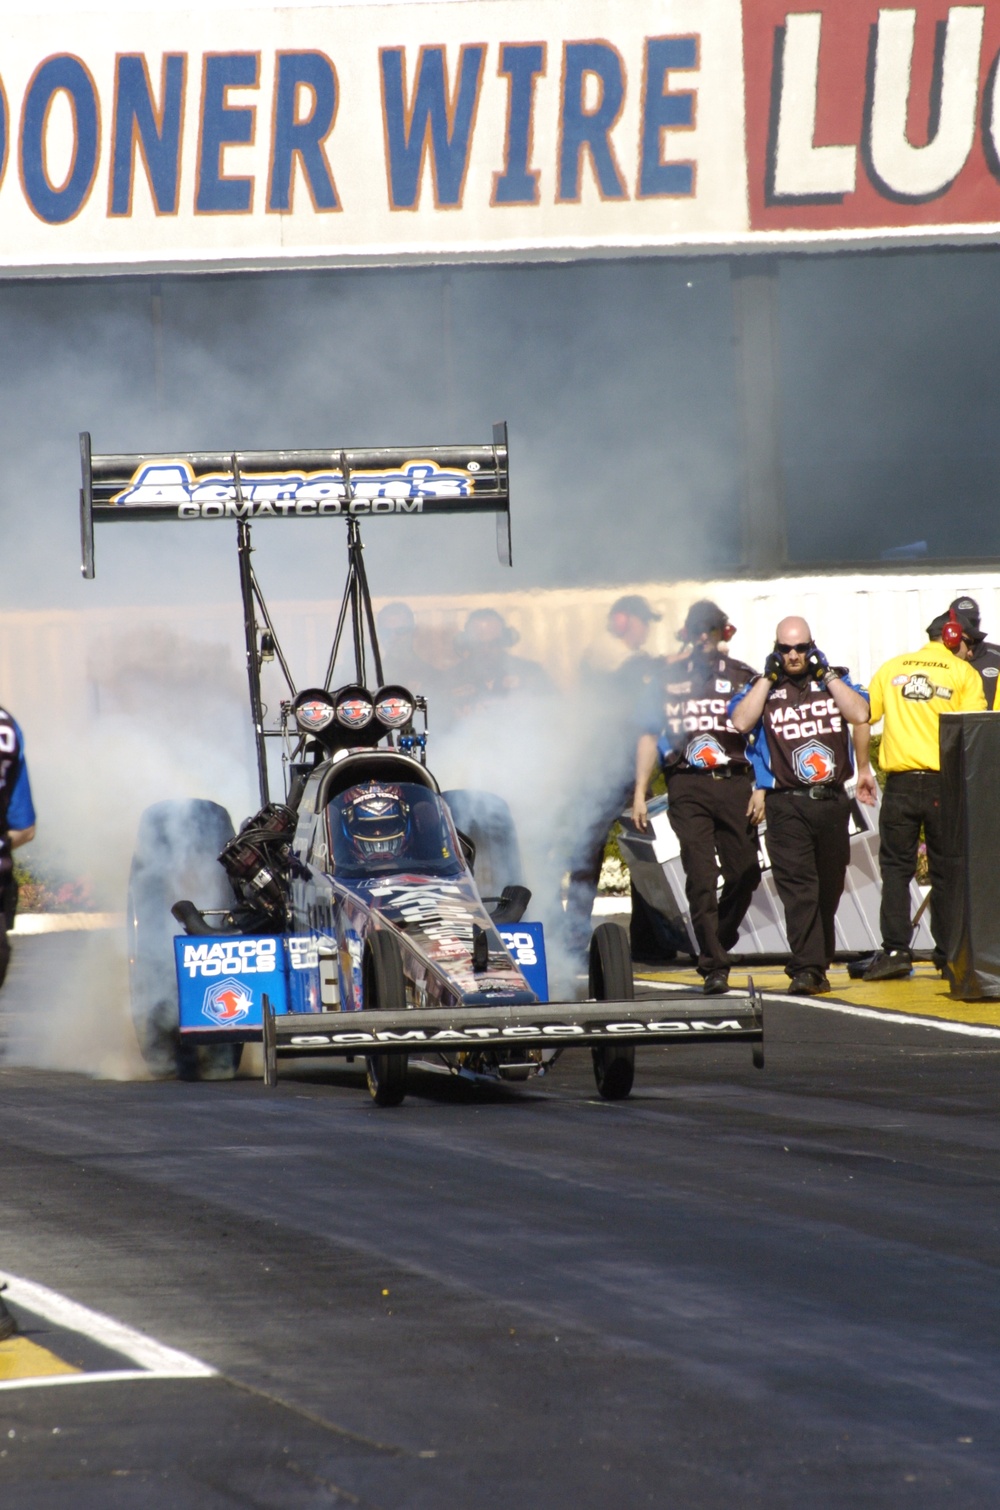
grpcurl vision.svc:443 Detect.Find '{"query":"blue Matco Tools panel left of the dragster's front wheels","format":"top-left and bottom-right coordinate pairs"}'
top-left (174, 933), bottom-right (289, 1036)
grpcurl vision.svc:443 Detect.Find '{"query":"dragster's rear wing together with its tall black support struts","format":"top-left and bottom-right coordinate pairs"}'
top-left (80, 423), bottom-right (512, 803)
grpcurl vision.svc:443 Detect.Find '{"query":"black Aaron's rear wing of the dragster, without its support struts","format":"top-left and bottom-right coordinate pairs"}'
top-left (80, 424), bottom-right (511, 578)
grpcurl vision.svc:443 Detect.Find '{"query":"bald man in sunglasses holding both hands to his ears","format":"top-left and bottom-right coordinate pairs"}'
top-left (730, 618), bottom-right (869, 997)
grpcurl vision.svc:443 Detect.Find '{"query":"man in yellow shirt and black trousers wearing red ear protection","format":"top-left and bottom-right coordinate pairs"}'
top-left (855, 609), bottom-right (986, 980)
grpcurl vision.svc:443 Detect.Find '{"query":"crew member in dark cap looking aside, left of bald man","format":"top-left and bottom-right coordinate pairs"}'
top-left (631, 601), bottom-right (763, 997)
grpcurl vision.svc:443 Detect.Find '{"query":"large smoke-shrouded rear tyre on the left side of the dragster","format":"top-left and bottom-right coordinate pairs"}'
top-left (125, 800), bottom-right (242, 1080)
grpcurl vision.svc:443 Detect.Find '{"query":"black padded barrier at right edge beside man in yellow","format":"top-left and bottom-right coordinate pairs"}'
top-left (941, 713), bottom-right (1000, 1001)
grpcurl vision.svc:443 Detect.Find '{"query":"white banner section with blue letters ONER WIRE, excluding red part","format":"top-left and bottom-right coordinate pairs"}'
top-left (0, 0), bottom-right (746, 270)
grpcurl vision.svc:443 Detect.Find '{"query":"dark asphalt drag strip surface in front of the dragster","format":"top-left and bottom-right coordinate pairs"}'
top-left (0, 945), bottom-right (1000, 1510)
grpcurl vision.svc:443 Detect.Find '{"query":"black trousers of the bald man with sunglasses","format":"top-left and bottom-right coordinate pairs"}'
top-left (766, 791), bottom-right (850, 975)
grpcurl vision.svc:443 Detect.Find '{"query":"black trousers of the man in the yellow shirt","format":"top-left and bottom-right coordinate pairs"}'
top-left (879, 770), bottom-right (947, 960)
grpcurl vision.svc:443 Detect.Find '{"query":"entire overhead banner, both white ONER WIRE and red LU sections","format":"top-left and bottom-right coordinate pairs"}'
top-left (0, 0), bottom-right (1000, 273)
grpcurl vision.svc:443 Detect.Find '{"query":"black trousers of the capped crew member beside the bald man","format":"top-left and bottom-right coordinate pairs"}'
top-left (666, 770), bottom-right (760, 975)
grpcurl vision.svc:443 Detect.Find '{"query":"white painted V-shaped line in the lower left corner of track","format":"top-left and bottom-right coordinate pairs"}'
top-left (0, 1271), bottom-right (218, 1389)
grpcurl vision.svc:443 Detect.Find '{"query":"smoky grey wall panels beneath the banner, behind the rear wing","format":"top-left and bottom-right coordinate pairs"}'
top-left (0, 251), bottom-right (1000, 607)
